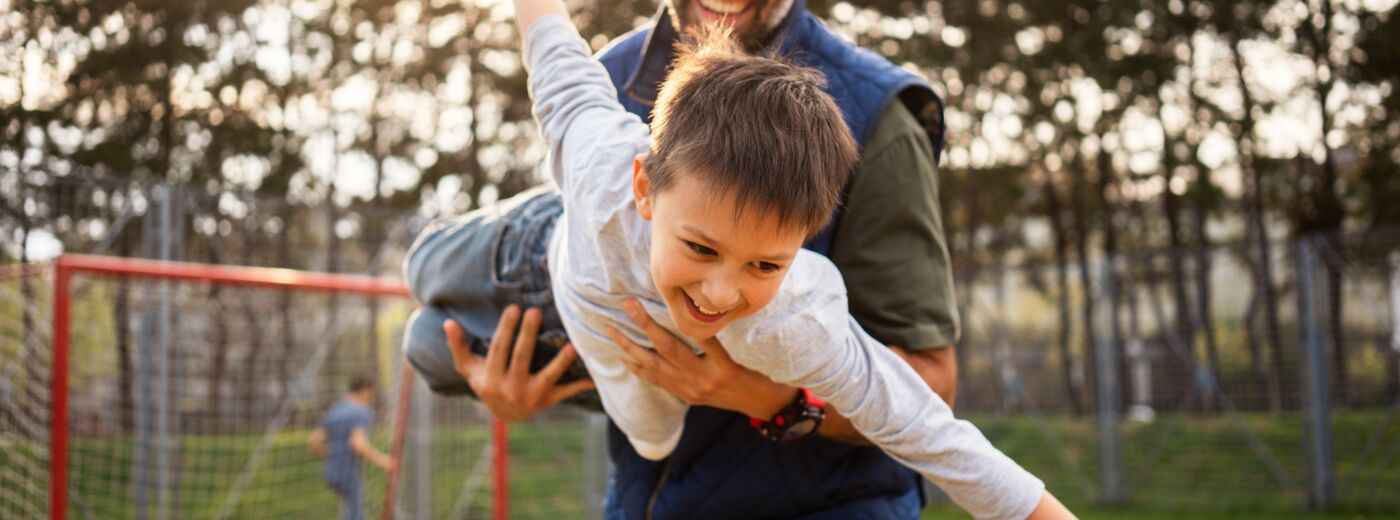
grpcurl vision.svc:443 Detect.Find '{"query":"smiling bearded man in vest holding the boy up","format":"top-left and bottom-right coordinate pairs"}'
top-left (420, 0), bottom-right (958, 519)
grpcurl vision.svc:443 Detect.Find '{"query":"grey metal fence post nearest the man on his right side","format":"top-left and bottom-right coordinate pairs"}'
top-left (1088, 256), bottom-right (1126, 505)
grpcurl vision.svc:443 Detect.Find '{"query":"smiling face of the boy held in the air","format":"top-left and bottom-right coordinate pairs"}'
top-left (633, 157), bottom-right (806, 344)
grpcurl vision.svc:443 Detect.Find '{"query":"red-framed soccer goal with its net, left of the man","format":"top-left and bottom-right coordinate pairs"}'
top-left (0, 256), bottom-right (606, 519)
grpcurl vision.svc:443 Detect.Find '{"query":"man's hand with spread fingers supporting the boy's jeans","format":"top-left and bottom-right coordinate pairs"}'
top-left (442, 306), bottom-right (594, 422)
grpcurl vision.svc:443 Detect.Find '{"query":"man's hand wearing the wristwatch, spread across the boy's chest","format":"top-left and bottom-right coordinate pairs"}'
top-left (608, 299), bottom-right (797, 420)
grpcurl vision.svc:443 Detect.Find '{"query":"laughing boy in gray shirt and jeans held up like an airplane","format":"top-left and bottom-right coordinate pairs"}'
top-left (406, 0), bottom-right (1068, 519)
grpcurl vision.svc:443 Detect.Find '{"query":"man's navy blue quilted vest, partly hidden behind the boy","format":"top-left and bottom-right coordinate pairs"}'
top-left (599, 0), bottom-right (944, 519)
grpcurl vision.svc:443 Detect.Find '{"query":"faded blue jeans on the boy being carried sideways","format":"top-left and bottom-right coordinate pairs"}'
top-left (403, 186), bottom-right (602, 411)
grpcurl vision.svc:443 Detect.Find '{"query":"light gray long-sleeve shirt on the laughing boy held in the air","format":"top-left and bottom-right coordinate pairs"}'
top-left (525, 17), bottom-right (1044, 519)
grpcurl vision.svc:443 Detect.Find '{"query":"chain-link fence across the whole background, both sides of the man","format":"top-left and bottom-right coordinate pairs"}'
top-left (0, 172), bottom-right (1400, 519)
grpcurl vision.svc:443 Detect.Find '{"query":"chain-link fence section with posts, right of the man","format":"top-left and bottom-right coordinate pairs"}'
top-left (959, 228), bottom-right (1400, 512)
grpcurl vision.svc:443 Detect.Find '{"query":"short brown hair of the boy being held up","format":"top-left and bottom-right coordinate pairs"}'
top-left (647, 29), bottom-right (858, 234)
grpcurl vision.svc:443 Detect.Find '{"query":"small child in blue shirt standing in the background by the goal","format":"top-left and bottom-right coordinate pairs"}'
top-left (307, 377), bottom-right (393, 520)
